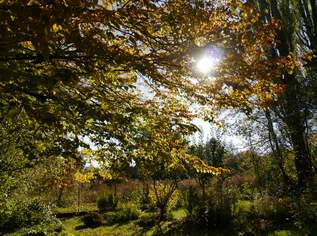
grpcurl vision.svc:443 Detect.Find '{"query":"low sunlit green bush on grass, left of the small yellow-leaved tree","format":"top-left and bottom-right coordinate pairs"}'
top-left (105, 203), bottom-right (140, 224)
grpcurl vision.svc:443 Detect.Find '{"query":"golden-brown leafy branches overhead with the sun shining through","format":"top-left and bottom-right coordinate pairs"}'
top-left (0, 0), bottom-right (313, 181)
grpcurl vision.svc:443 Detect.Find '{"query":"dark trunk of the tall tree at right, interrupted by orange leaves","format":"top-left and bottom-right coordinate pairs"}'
top-left (258, 0), bottom-right (313, 189)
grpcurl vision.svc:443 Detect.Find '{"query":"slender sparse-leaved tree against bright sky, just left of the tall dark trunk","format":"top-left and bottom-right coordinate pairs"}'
top-left (230, 107), bottom-right (295, 193)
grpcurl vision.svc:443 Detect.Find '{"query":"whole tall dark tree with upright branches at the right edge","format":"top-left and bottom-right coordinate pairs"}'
top-left (252, 0), bottom-right (316, 189)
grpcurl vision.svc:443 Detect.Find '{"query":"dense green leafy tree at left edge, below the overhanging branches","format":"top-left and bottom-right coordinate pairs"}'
top-left (0, 112), bottom-right (76, 202)
